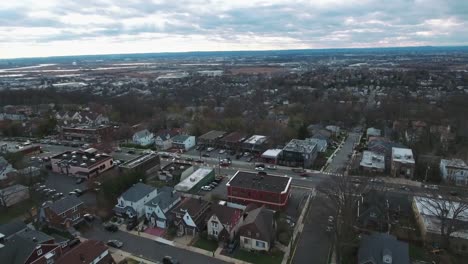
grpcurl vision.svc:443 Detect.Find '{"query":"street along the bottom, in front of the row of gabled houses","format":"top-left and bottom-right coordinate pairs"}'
top-left (82, 222), bottom-right (226, 264)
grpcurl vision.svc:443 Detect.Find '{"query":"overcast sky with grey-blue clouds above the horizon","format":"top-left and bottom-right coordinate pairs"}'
top-left (0, 0), bottom-right (468, 58)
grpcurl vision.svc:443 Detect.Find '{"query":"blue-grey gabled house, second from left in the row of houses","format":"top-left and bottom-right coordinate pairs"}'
top-left (145, 186), bottom-right (181, 228)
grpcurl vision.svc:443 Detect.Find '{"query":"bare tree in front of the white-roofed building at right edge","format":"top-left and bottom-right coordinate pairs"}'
top-left (416, 194), bottom-right (468, 249)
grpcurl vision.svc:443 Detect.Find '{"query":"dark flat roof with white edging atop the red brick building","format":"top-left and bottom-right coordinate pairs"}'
top-left (226, 171), bottom-right (292, 193)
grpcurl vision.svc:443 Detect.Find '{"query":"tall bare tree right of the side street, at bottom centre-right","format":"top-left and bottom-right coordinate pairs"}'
top-left (317, 176), bottom-right (368, 263)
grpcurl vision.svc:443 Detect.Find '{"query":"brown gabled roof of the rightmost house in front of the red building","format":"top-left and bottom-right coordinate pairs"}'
top-left (240, 206), bottom-right (274, 241)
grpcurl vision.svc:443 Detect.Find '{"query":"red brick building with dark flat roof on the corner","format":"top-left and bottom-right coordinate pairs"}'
top-left (226, 171), bottom-right (292, 210)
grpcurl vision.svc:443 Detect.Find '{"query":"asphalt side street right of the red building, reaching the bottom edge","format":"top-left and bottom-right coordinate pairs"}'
top-left (292, 196), bottom-right (331, 264)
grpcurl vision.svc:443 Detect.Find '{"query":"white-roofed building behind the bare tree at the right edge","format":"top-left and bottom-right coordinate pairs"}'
top-left (413, 196), bottom-right (468, 254)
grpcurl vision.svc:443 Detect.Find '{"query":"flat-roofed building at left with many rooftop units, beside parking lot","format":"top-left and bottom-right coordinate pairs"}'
top-left (50, 148), bottom-right (114, 178)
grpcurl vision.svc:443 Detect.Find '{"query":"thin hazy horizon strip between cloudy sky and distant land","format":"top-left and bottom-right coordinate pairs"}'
top-left (0, 44), bottom-right (468, 61)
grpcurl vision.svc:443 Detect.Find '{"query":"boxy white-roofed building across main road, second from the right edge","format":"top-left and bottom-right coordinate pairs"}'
top-left (391, 147), bottom-right (415, 179)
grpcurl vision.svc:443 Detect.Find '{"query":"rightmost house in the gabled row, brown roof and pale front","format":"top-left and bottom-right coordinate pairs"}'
top-left (239, 206), bottom-right (276, 251)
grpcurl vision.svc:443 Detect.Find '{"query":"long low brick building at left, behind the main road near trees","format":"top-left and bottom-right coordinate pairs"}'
top-left (61, 125), bottom-right (113, 143)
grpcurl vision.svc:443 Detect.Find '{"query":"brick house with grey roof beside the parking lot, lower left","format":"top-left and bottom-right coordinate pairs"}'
top-left (39, 195), bottom-right (87, 230)
